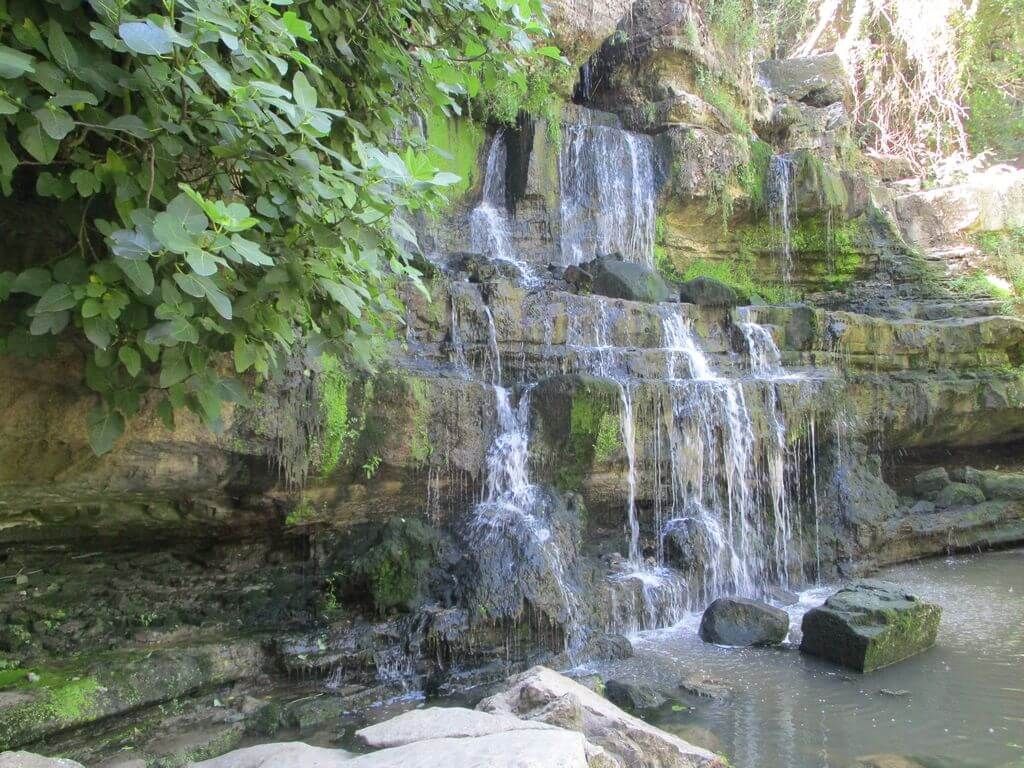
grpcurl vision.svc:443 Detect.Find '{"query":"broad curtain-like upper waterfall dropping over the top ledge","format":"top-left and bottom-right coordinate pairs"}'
top-left (558, 118), bottom-right (654, 266)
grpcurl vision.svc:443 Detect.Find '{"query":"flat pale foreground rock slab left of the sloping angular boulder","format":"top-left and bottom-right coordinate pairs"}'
top-left (355, 707), bottom-right (554, 750)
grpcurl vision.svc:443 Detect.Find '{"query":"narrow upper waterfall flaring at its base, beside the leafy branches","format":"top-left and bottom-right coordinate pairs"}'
top-left (469, 131), bottom-right (537, 284)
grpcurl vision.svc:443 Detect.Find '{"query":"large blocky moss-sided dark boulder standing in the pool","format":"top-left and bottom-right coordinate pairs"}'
top-left (800, 580), bottom-right (942, 672)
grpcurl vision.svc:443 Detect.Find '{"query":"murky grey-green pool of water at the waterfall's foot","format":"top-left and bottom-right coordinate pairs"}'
top-left (598, 550), bottom-right (1024, 768)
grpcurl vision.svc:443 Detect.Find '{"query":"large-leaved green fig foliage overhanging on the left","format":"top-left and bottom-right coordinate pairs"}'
top-left (0, 0), bottom-right (558, 454)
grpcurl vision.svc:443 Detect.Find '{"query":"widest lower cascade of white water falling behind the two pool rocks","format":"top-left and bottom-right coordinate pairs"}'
top-left (662, 308), bottom-right (799, 604)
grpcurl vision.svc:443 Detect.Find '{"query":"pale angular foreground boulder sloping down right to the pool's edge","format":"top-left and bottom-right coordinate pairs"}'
top-left (477, 667), bottom-right (725, 768)
